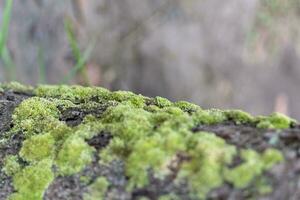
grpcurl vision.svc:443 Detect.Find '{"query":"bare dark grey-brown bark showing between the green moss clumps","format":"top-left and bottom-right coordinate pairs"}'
top-left (0, 91), bottom-right (300, 200)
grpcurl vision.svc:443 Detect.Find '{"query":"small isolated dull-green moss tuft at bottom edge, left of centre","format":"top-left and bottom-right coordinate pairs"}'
top-left (83, 177), bottom-right (109, 200)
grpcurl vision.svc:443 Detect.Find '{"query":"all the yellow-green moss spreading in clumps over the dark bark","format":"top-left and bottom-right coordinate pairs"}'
top-left (3, 82), bottom-right (295, 200)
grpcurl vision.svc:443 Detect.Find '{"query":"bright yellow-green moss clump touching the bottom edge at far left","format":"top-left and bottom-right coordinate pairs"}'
top-left (10, 159), bottom-right (54, 200)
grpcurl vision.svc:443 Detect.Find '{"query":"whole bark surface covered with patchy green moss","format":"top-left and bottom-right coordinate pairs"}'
top-left (0, 83), bottom-right (300, 200)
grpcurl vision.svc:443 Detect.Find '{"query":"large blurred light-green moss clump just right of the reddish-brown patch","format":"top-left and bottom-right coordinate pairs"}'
top-left (180, 132), bottom-right (236, 198)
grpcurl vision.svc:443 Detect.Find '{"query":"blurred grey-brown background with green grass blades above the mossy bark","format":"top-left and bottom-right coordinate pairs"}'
top-left (0, 0), bottom-right (300, 119)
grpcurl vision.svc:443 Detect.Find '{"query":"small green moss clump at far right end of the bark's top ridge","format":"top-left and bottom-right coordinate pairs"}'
top-left (256, 113), bottom-right (296, 129)
